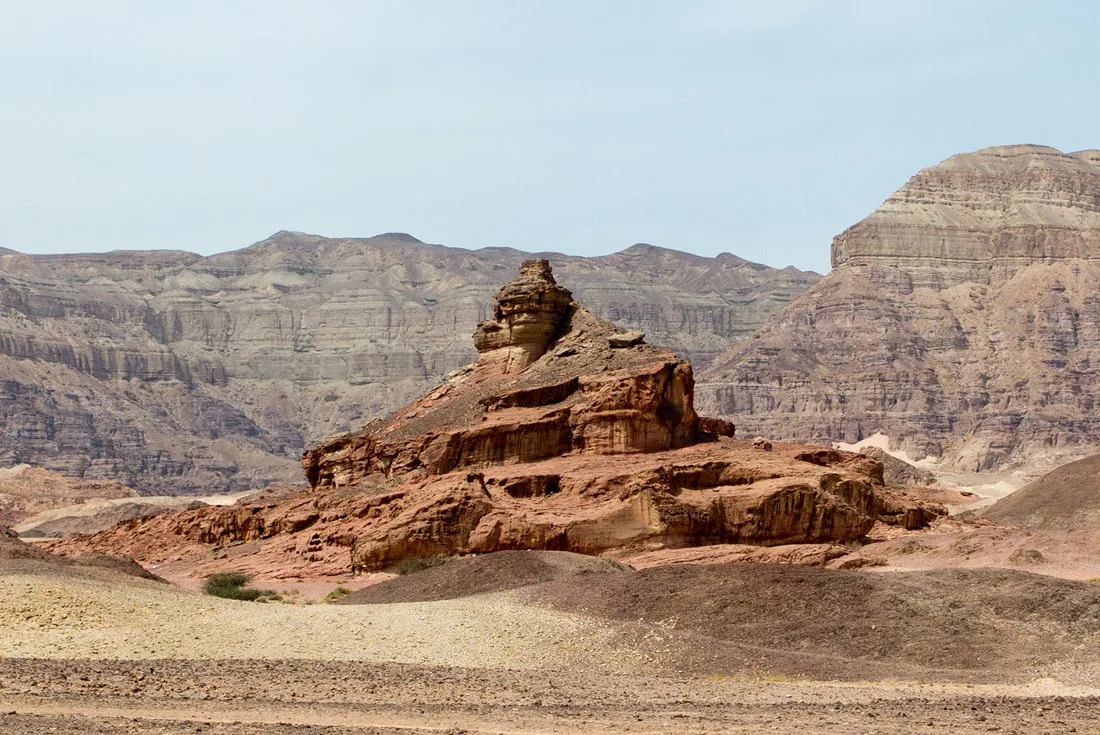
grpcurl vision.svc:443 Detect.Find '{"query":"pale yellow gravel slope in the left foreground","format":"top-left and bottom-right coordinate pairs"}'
top-left (0, 572), bottom-right (629, 669)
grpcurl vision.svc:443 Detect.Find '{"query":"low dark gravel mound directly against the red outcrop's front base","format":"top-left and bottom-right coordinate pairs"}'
top-left (338, 551), bottom-right (633, 605)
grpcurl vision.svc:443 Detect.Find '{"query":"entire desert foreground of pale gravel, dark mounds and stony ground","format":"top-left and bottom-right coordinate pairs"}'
top-left (0, 552), bottom-right (1100, 735)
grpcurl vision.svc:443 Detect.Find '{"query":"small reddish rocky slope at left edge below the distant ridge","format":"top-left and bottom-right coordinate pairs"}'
top-left (0, 464), bottom-right (138, 526)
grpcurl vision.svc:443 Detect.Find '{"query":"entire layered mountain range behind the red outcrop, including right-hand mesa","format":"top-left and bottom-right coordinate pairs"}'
top-left (8, 145), bottom-right (1100, 493)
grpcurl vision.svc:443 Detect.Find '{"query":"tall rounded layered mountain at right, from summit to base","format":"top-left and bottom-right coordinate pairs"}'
top-left (700, 145), bottom-right (1100, 471)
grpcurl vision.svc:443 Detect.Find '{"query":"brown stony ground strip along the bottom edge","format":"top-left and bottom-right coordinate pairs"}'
top-left (0, 660), bottom-right (1100, 735)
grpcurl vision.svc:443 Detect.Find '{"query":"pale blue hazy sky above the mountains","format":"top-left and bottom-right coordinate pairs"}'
top-left (0, 0), bottom-right (1100, 272)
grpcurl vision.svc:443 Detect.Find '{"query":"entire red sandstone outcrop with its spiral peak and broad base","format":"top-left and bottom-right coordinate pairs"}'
top-left (57, 261), bottom-right (882, 575)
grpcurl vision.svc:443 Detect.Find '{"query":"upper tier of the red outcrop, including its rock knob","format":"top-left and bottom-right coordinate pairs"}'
top-left (303, 260), bottom-right (734, 487)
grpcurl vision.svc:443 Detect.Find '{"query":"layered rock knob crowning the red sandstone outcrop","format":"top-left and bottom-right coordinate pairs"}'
top-left (474, 260), bottom-right (573, 374)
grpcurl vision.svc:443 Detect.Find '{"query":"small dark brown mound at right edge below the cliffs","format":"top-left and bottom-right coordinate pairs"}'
top-left (985, 454), bottom-right (1100, 534)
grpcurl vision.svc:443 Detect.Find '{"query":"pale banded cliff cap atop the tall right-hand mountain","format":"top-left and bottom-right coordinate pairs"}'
top-left (833, 145), bottom-right (1100, 288)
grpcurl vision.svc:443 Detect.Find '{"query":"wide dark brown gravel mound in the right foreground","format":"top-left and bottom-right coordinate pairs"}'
top-left (528, 563), bottom-right (1100, 680)
